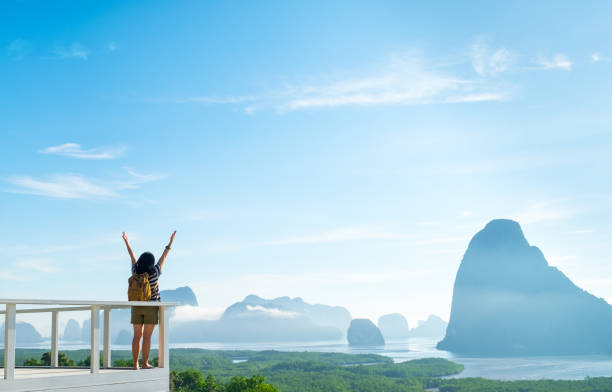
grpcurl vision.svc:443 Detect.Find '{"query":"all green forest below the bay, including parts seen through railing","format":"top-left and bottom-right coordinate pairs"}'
top-left (13, 349), bottom-right (612, 392)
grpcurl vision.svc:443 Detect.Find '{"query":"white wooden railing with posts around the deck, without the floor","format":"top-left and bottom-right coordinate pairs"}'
top-left (0, 299), bottom-right (179, 381)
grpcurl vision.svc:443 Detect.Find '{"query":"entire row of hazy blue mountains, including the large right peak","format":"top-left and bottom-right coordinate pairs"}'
top-left (11, 219), bottom-right (612, 356)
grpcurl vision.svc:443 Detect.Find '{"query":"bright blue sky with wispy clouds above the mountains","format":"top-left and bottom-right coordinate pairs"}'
top-left (0, 1), bottom-right (612, 325)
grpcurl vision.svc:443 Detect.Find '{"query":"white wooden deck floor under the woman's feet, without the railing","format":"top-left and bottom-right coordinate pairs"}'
top-left (0, 367), bottom-right (169, 392)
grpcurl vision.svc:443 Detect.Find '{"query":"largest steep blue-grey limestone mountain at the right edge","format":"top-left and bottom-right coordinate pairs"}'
top-left (438, 219), bottom-right (612, 356)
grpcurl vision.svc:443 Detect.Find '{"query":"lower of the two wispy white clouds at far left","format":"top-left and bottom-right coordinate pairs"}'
top-left (7, 170), bottom-right (166, 199)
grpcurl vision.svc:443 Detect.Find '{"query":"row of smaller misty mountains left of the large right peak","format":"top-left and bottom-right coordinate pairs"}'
top-left (7, 287), bottom-right (445, 345)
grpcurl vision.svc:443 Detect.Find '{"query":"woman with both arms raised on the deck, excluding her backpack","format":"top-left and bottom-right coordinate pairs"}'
top-left (123, 230), bottom-right (176, 370)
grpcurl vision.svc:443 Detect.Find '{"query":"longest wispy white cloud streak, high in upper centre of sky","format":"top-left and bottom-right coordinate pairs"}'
top-left (166, 49), bottom-right (511, 111)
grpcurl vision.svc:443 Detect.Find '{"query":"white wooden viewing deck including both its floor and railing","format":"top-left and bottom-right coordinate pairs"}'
top-left (0, 299), bottom-right (178, 392)
